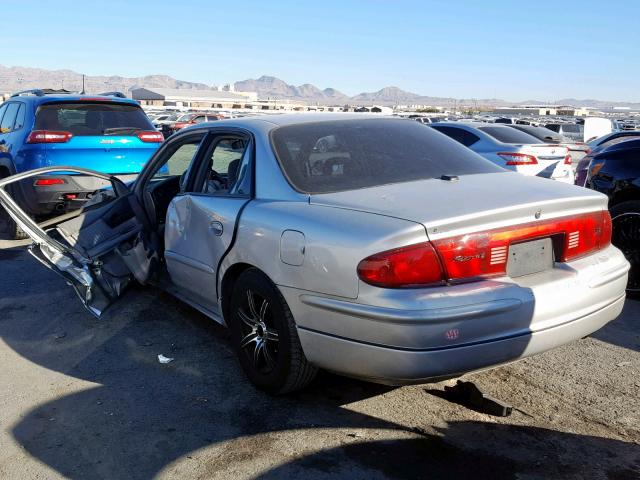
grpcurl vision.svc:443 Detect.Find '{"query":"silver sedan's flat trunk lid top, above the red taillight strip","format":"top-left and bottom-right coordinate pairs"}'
top-left (309, 172), bottom-right (607, 240)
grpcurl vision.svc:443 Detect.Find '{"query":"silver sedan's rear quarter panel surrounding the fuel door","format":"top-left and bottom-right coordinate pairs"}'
top-left (218, 200), bottom-right (427, 298)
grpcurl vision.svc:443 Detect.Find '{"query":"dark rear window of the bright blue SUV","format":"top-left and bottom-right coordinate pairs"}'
top-left (35, 102), bottom-right (154, 137)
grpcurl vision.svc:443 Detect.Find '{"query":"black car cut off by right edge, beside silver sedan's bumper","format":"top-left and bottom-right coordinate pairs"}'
top-left (585, 138), bottom-right (640, 296)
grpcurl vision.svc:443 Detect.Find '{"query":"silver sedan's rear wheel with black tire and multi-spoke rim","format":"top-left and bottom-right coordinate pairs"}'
top-left (229, 268), bottom-right (317, 394)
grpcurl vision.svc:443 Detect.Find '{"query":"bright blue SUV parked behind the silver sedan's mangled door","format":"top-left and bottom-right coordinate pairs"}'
top-left (0, 90), bottom-right (164, 238)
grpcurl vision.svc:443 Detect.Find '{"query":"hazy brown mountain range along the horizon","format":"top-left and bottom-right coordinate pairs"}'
top-left (0, 65), bottom-right (640, 109)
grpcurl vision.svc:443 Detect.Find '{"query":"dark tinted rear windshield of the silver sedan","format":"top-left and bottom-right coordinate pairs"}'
top-left (271, 119), bottom-right (503, 194)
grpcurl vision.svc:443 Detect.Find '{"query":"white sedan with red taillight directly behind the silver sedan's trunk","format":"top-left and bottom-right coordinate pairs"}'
top-left (430, 122), bottom-right (574, 184)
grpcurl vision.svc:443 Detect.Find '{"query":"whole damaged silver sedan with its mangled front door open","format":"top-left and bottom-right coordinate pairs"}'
top-left (0, 114), bottom-right (629, 393)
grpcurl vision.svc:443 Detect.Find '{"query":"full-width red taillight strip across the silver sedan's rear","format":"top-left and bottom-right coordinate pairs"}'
top-left (358, 211), bottom-right (611, 288)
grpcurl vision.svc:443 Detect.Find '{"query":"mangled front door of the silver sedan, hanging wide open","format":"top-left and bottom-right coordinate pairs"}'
top-left (0, 167), bottom-right (142, 316)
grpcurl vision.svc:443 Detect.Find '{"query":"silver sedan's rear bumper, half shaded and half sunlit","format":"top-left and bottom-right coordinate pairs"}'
top-left (280, 247), bottom-right (629, 384)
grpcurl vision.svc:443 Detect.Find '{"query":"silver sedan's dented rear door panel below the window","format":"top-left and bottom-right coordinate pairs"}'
top-left (164, 194), bottom-right (249, 313)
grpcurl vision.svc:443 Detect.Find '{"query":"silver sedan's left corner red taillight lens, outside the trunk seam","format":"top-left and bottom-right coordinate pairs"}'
top-left (358, 242), bottom-right (444, 288)
